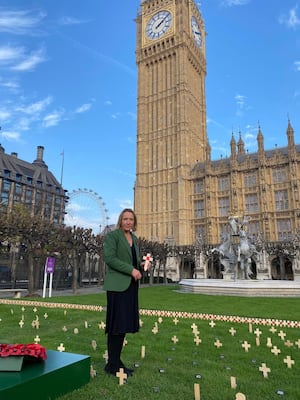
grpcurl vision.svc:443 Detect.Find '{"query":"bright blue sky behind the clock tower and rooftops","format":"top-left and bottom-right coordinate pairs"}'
top-left (0, 0), bottom-right (300, 230)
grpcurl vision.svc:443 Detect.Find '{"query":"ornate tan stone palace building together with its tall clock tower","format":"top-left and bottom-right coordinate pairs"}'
top-left (134, 0), bottom-right (300, 246)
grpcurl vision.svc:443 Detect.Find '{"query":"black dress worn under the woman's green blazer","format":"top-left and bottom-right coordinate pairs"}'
top-left (105, 245), bottom-right (140, 334)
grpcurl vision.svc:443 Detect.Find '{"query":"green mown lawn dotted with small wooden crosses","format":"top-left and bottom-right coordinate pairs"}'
top-left (0, 286), bottom-right (300, 400)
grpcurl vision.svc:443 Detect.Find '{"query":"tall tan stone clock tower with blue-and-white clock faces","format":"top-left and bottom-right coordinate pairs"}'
top-left (134, 0), bottom-right (208, 245)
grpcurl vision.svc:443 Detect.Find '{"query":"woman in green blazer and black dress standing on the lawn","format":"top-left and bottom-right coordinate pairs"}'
top-left (103, 208), bottom-right (142, 375)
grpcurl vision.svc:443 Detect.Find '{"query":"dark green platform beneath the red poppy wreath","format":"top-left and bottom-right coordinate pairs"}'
top-left (0, 350), bottom-right (91, 400)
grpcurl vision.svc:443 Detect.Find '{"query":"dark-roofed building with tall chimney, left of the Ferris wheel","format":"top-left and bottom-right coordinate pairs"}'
top-left (0, 145), bottom-right (67, 225)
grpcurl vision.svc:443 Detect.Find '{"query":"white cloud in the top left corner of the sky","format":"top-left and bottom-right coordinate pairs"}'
top-left (0, 7), bottom-right (46, 35)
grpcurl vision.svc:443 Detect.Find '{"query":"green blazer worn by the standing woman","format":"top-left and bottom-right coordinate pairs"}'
top-left (103, 229), bottom-right (141, 292)
